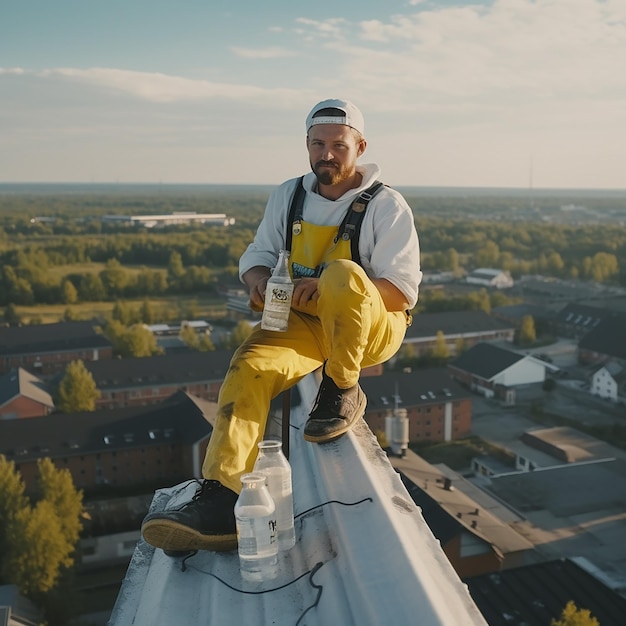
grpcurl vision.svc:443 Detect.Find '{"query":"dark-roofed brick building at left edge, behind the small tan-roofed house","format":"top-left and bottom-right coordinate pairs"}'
top-left (0, 322), bottom-right (113, 377)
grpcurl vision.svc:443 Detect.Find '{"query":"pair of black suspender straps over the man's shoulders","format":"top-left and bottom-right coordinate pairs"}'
top-left (285, 176), bottom-right (384, 265)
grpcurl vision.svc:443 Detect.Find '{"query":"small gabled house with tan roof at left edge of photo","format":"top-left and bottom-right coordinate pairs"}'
top-left (0, 367), bottom-right (54, 420)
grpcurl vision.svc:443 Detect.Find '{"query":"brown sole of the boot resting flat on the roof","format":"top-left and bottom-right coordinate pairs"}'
top-left (141, 520), bottom-right (237, 552)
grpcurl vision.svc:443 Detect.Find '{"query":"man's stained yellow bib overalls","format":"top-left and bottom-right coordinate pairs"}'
top-left (202, 214), bottom-right (407, 493)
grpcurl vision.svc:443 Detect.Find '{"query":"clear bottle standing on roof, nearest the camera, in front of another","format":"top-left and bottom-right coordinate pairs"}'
top-left (235, 472), bottom-right (278, 582)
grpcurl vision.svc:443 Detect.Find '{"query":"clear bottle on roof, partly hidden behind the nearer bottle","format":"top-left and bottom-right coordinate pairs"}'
top-left (254, 440), bottom-right (296, 550)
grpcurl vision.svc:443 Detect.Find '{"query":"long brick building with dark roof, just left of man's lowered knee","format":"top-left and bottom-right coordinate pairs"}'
top-left (85, 350), bottom-right (233, 409)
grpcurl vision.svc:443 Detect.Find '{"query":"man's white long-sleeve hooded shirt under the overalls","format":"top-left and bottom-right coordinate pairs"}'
top-left (239, 164), bottom-right (422, 308)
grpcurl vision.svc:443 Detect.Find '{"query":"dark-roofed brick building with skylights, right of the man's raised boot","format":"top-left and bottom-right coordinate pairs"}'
top-left (360, 368), bottom-right (472, 442)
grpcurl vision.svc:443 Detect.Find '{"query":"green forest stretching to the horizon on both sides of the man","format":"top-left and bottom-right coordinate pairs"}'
top-left (0, 185), bottom-right (626, 314)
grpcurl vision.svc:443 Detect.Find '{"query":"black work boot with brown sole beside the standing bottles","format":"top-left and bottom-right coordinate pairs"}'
top-left (141, 480), bottom-right (239, 553)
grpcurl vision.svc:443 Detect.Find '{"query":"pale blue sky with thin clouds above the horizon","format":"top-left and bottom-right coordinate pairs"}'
top-left (0, 0), bottom-right (626, 189)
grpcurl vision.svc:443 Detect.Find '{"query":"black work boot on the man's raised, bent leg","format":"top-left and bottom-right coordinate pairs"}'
top-left (304, 370), bottom-right (367, 443)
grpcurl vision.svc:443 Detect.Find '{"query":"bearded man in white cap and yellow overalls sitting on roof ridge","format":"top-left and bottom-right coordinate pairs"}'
top-left (142, 100), bottom-right (422, 551)
